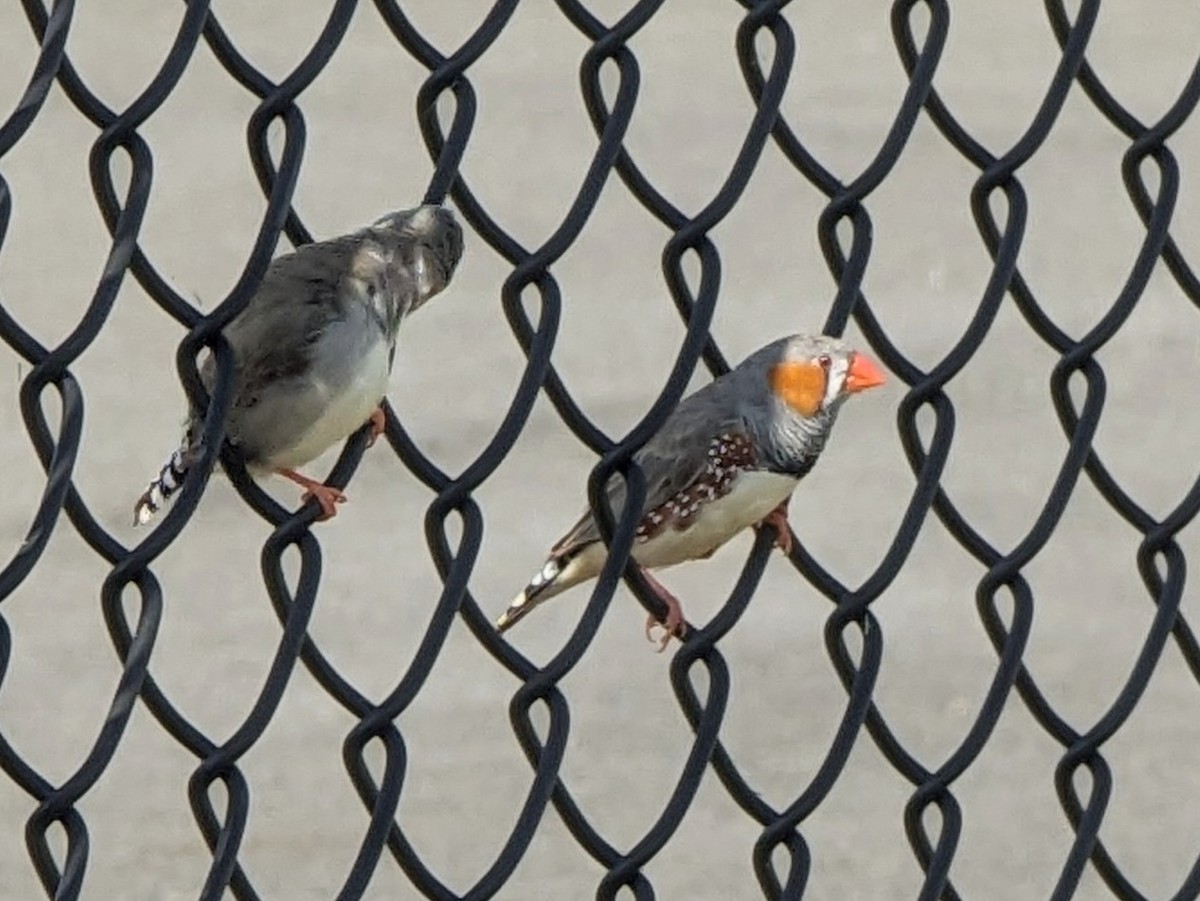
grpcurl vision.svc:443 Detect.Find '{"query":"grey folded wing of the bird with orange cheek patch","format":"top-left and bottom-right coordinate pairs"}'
top-left (551, 382), bottom-right (743, 557)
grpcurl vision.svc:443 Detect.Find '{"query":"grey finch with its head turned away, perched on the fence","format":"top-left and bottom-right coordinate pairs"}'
top-left (133, 205), bottom-right (462, 525)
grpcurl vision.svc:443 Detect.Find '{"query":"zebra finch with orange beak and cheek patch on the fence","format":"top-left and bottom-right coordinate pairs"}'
top-left (496, 335), bottom-right (883, 650)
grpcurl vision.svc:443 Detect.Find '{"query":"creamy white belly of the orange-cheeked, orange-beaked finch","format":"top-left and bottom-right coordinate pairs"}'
top-left (634, 471), bottom-right (798, 569)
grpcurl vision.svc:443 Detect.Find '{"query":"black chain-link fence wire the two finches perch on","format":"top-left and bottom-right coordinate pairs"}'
top-left (0, 0), bottom-right (1200, 899)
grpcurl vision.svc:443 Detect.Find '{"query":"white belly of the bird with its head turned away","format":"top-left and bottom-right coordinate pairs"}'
top-left (271, 341), bottom-right (388, 469)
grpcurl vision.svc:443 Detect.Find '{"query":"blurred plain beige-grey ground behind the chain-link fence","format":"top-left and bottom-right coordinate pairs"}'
top-left (0, 0), bottom-right (1200, 899)
